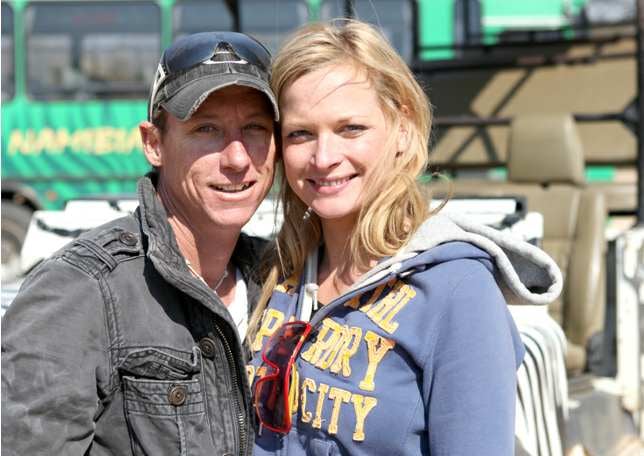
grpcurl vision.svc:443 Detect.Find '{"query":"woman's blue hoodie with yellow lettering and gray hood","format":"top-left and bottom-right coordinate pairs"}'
top-left (249, 215), bottom-right (562, 456)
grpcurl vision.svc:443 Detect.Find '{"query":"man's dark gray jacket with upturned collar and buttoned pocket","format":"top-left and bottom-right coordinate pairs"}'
top-left (2, 177), bottom-right (263, 456)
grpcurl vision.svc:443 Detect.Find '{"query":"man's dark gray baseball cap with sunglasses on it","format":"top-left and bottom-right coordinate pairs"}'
top-left (148, 32), bottom-right (279, 121)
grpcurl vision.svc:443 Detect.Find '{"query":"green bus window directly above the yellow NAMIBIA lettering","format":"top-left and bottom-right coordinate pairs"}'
top-left (25, 1), bottom-right (161, 100)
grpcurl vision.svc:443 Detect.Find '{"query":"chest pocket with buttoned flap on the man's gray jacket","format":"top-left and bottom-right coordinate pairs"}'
top-left (119, 349), bottom-right (212, 456)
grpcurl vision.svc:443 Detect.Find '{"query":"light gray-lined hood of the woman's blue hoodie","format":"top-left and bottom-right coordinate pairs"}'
top-left (349, 214), bottom-right (563, 305)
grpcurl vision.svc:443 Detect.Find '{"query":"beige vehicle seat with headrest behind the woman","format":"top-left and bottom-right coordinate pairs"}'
top-left (432, 114), bottom-right (607, 373)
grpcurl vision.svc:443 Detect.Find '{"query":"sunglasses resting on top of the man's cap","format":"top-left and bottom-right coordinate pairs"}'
top-left (148, 32), bottom-right (271, 120)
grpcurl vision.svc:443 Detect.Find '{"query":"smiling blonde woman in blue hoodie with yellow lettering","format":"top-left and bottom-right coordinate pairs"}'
top-left (248, 21), bottom-right (561, 456)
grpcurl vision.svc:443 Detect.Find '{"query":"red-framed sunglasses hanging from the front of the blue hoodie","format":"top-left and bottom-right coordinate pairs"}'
top-left (255, 321), bottom-right (311, 434)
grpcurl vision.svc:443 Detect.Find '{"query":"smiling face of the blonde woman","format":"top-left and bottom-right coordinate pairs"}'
top-left (280, 65), bottom-right (389, 227)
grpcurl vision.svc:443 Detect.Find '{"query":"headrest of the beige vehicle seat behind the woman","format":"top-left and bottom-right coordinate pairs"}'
top-left (508, 114), bottom-right (585, 185)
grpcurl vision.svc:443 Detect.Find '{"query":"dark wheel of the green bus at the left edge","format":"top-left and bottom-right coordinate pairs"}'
top-left (1, 201), bottom-right (31, 282)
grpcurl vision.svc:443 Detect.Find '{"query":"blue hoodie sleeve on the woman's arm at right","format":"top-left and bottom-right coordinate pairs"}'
top-left (424, 260), bottom-right (524, 456)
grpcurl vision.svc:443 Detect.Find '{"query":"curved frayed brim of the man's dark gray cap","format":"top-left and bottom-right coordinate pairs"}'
top-left (160, 73), bottom-right (279, 122)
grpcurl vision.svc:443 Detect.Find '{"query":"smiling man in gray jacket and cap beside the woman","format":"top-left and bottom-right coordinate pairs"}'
top-left (2, 33), bottom-right (278, 456)
